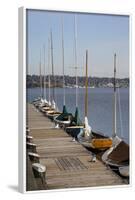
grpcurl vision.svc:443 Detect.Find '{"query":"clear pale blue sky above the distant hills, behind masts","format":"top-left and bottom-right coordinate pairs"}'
top-left (26, 10), bottom-right (129, 78)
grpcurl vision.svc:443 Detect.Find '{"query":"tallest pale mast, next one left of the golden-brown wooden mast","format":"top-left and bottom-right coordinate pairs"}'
top-left (74, 15), bottom-right (78, 108)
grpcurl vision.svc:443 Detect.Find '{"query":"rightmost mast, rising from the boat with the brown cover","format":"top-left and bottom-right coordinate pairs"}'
top-left (112, 53), bottom-right (117, 137)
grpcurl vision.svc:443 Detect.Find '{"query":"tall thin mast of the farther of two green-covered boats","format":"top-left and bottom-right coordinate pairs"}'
top-left (61, 18), bottom-right (66, 106)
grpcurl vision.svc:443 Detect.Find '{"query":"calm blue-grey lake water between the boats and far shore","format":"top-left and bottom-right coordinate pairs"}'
top-left (27, 88), bottom-right (129, 143)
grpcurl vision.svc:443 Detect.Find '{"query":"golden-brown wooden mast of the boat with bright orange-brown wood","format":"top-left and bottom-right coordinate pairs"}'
top-left (85, 50), bottom-right (88, 117)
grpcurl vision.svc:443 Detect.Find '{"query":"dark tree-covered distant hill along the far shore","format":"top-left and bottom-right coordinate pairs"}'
top-left (26, 75), bottom-right (129, 88)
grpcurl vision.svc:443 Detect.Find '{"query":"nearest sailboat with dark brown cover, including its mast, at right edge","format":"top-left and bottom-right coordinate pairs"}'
top-left (102, 54), bottom-right (129, 175)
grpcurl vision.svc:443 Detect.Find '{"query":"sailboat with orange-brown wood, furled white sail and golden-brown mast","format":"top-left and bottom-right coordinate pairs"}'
top-left (77, 50), bottom-right (112, 151)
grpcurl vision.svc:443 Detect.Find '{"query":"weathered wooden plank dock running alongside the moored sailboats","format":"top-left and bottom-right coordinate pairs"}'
top-left (27, 104), bottom-right (125, 190)
